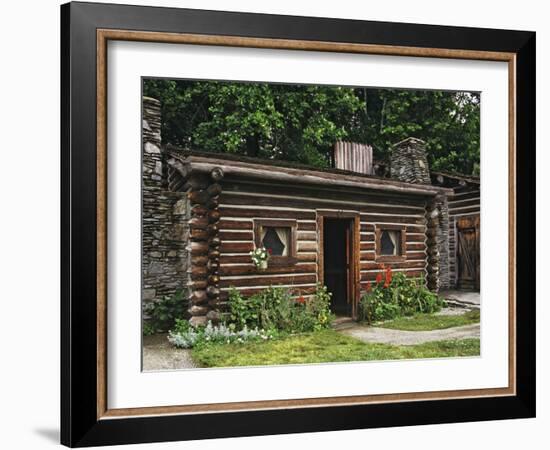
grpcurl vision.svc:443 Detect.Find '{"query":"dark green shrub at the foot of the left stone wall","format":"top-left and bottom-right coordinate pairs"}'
top-left (143, 291), bottom-right (188, 336)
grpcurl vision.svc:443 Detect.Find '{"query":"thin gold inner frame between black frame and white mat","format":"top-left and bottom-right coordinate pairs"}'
top-left (96, 29), bottom-right (516, 420)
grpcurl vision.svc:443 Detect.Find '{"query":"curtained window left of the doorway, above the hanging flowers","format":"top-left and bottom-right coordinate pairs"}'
top-left (254, 219), bottom-right (296, 265)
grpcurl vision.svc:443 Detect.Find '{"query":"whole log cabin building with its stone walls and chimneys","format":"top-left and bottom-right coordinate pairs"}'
top-left (142, 98), bottom-right (479, 324)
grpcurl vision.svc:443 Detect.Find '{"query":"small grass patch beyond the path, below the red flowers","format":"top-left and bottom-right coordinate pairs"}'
top-left (375, 309), bottom-right (479, 331)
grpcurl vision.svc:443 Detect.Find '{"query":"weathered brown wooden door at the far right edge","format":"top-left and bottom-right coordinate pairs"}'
top-left (456, 215), bottom-right (480, 290)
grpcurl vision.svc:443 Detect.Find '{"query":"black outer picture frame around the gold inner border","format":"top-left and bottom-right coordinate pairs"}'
top-left (61, 2), bottom-right (536, 447)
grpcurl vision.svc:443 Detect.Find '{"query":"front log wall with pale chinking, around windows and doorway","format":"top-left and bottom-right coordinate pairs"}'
top-left (219, 181), bottom-right (432, 306)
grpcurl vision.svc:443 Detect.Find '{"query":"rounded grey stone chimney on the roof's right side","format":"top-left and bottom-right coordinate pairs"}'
top-left (390, 137), bottom-right (431, 184)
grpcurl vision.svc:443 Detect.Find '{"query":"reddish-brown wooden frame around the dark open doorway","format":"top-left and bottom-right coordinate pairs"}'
top-left (317, 209), bottom-right (361, 319)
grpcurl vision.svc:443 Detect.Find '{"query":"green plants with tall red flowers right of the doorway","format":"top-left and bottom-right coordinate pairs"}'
top-left (359, 269), bottom-right (444, 324)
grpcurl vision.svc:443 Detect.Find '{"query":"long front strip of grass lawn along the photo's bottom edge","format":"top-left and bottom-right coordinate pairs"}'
top-left (192, 330), bottom-right (480, 367)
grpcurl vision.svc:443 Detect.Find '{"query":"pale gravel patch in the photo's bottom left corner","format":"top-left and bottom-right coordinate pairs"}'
top-left (143, 334), bottom-right (197, 372)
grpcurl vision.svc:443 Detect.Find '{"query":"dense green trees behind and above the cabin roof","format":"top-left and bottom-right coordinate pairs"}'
top-left (143, 79), bottom-right (480, 175)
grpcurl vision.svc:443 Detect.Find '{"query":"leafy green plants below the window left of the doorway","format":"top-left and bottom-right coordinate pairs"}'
top-left (226, 286), bottom-right (332, 333)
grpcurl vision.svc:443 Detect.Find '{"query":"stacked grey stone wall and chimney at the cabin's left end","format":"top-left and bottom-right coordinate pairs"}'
top-left (142, 97), bottom-right (189, 306)
